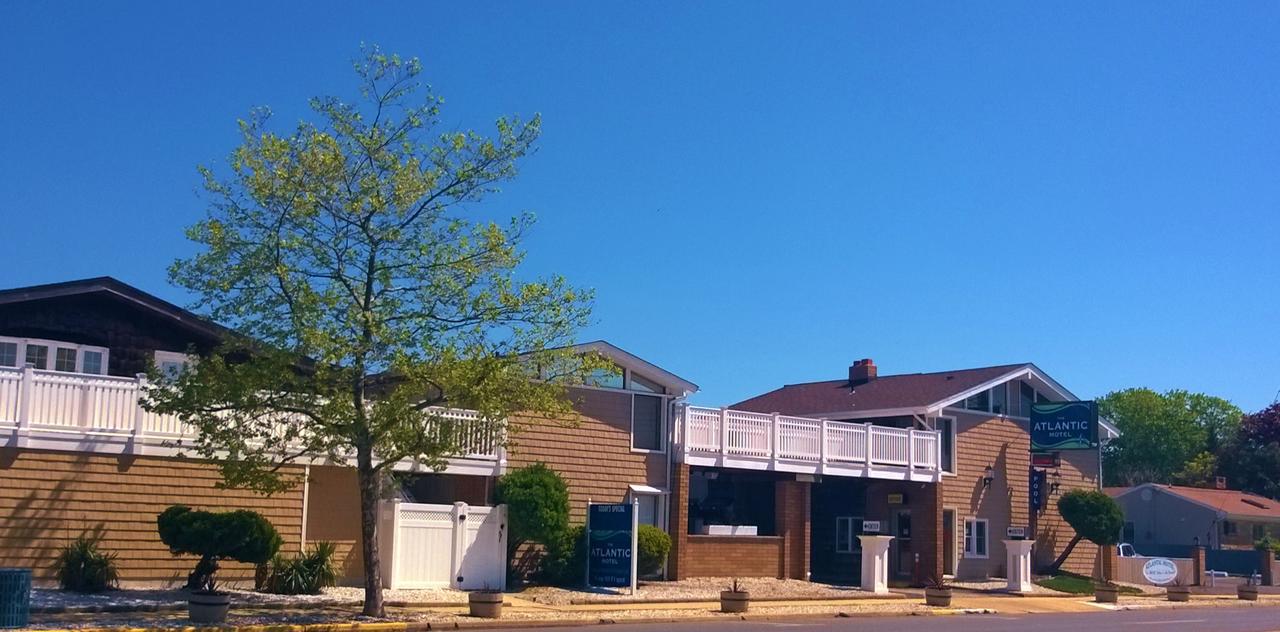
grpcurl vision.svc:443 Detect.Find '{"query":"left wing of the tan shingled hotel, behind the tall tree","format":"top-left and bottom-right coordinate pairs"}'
top-left (0, 278), bottom-right (696, 583)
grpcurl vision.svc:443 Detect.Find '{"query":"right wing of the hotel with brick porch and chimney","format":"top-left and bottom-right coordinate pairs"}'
top-left (671, 359), bottom-right (1114, 582)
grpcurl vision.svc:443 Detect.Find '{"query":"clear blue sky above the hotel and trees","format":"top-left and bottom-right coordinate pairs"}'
top-left (0, 1), bottom-right (1280, 409)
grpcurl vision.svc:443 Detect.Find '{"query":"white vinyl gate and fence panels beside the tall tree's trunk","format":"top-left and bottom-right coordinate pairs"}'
top-left (378, 500), bottom-right (507, 590)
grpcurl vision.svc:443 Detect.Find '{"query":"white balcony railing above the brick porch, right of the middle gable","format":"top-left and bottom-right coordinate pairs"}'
top-left (677, 406), bottom-right (942, 480)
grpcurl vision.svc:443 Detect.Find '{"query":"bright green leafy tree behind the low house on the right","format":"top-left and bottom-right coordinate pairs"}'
top-left (1098, 389), bottom-right (1240, 485)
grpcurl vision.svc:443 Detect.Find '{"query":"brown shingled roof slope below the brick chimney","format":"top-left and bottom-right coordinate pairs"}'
top-left (730, 363), bottom-right (1030, 415)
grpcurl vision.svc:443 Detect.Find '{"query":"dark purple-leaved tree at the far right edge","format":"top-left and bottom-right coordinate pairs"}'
top-left (1221, 402), bottom-right (1280, 499)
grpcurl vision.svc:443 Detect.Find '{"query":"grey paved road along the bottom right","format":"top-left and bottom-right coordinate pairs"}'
top-left (524, 608), bottom-right (1280, 632)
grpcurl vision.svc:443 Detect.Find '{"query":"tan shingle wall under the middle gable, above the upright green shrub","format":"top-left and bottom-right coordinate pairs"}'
top-left (508, 389), bottom-right (668, 523)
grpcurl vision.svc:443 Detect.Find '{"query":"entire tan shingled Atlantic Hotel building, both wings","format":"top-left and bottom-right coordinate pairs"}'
top-left (0, 278), bottom-right (1114, 589)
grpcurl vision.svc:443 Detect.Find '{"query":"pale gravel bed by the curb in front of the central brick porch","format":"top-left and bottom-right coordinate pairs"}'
top-left (516, 577), bottom-right (870, 605)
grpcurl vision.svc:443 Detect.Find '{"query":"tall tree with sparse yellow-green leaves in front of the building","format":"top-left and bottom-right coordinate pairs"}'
top-left (148, 49), bottom-right (594, 617)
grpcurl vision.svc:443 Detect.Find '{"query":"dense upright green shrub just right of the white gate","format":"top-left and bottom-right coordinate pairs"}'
top-left (493, 463), bottom-right (570, 575)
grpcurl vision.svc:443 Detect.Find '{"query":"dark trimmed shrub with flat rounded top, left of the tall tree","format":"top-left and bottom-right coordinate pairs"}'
top-left (156, 505), bottom-right (283, 591)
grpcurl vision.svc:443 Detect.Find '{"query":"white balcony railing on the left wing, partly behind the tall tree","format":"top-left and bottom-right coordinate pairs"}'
top-left (0, 367), bottom-right (502, 470)
